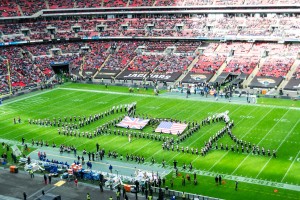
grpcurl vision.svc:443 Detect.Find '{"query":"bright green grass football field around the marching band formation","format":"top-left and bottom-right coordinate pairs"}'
top-left (0, 84), bottom-right (300, 199)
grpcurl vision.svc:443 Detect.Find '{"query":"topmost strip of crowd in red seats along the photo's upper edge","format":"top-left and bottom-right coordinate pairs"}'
top-left (0, 0), bottom-right (297, 17)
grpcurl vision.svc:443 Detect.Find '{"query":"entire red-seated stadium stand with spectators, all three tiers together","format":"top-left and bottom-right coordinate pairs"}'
top-left (0, 0), bottom-right (300, 93)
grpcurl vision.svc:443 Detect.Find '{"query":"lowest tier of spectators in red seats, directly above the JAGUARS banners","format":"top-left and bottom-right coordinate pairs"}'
top-left (0, 41), bottom-right (300, 93)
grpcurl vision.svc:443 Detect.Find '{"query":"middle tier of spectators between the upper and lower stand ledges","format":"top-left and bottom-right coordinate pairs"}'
top-left (0, 14), bottom-right (300, 39)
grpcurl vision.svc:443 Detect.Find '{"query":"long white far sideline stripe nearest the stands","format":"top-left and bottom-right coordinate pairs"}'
top-left (57, 88), bottom-right (300, 110)
